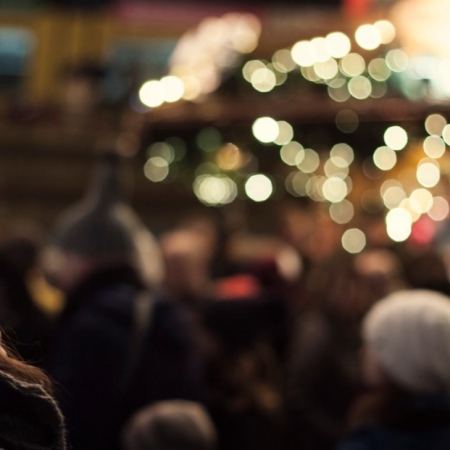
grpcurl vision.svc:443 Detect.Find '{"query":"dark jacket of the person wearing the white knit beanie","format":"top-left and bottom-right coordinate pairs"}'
top-left (337, 394), bottom-right (450, 450)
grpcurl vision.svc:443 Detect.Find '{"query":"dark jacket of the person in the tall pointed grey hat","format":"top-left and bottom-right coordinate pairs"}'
top-left (50, 266), bottom-right (204, 450)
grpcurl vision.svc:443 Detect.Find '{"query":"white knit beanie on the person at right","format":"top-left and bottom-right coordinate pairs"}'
top-left (363, 290), bottom-right (450, 393)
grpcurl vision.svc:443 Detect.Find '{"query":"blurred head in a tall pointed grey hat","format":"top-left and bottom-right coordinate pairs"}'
top-left (43, 155), bottom-right (163, 291)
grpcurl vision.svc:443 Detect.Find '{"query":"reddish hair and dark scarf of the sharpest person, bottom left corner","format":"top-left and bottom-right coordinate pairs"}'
top-left (0, 332), bottom-right (66, 450)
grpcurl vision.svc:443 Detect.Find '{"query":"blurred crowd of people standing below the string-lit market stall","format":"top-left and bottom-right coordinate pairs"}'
top-left (0, 154), bottom-right (450, 450)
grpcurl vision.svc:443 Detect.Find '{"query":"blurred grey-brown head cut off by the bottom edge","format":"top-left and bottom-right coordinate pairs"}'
top-left (123, 400), bottom-right (217, 450)
